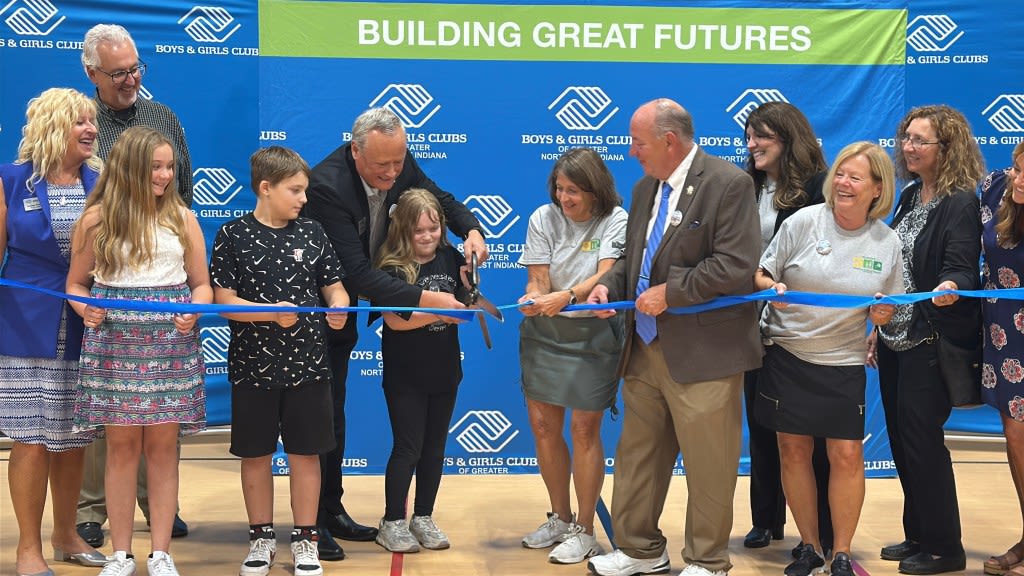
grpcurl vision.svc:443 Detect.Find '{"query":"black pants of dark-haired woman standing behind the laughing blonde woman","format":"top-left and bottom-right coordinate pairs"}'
top-left (743, 370), bottom-right (834, 548)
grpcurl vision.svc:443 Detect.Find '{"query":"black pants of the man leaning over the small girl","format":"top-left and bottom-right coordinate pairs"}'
top-left (317, 323), bottom-right (359, 525)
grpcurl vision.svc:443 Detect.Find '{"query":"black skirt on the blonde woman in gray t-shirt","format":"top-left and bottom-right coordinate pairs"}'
top-left (754, 344), bottom-right (866, 440)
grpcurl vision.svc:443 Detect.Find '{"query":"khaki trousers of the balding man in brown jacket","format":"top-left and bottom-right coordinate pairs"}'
top-left (611, 335), bottom-right (743, 572)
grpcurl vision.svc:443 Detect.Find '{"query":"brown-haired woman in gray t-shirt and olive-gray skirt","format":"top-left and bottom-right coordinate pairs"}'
top-left (519, 148), bottom-right (628, 564)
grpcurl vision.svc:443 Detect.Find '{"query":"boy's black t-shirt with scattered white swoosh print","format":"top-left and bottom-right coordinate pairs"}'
top-left (210, 213), bottom-right (344, 388)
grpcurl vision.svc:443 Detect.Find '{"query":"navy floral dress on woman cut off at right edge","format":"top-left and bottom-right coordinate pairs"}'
top-left (981, 170), bottom-right (1024, 422)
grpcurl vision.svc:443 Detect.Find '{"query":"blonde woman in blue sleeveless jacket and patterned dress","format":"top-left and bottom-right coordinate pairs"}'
top-left (0, 88), bottom-right (106, 576)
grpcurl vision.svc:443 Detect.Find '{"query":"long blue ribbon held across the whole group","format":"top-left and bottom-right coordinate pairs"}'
top-left (0, 278), bottom-right (1024, 320)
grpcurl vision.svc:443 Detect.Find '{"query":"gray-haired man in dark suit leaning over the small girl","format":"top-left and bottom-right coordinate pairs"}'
top-left (303, 108), bottom-right (487, 560)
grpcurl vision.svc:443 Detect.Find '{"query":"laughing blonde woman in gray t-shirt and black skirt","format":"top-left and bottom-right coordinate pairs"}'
top-left (754, 141), bottom-right (904, 576)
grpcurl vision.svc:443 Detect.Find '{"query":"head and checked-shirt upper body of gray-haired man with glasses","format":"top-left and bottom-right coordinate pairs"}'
top-left (82, 24), bottom-right (193, 207)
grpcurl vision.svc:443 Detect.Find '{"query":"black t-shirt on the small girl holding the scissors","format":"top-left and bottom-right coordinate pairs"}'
top-left (381, 246), bottom-right (466, 394)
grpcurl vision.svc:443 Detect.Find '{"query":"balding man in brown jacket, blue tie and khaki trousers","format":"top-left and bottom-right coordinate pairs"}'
top-left (589, 99), bottom-right (762, 576)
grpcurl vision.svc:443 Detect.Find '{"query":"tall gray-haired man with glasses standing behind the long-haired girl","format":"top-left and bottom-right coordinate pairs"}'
top-left (76, 24), bottom-right (193, 548)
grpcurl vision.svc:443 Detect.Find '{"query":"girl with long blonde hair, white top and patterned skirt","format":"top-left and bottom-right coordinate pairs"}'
top-left (68, 126), bottom-right (213, 576)
